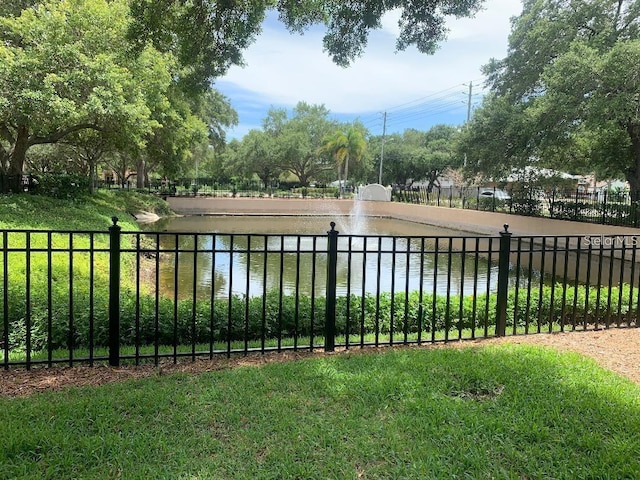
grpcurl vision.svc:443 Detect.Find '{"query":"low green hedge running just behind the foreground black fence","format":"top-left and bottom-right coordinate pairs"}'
top-left (0, 284), bottom-right (638, 351)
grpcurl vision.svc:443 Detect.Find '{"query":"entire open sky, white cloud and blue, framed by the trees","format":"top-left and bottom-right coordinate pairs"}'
top-left (214, 0), bottom-right (522, 139)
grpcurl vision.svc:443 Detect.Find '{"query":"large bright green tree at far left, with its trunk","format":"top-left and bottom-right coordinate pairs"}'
top-left (0, 0), bottom-right (170, 182)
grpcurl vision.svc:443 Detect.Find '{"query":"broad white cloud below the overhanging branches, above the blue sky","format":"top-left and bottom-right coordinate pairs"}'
top-left (218, 0), bottom-right (521, 134)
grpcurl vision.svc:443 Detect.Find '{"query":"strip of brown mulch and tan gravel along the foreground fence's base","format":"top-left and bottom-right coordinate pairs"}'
top-left (0, 328), bottom-right (640, 397)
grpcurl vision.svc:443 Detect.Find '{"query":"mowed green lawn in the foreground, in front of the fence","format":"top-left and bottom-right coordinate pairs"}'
top-left (0, 345), bottom-right (640, 479)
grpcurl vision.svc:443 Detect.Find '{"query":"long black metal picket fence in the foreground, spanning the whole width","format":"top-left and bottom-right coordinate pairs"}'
top-left (0, 219), bottom-right (640, 369)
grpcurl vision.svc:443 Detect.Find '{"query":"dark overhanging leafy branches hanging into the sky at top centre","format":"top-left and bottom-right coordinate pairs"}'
top-left (130, 0), bottom-right (484, 88)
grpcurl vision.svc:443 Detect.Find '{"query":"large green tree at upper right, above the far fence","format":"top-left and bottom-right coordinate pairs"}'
top-left (480, 0), bottom-right (640, 192)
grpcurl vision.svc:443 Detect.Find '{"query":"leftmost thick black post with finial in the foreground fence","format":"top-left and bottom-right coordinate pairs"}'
top-left (109, 217), bottom-right (122, 367)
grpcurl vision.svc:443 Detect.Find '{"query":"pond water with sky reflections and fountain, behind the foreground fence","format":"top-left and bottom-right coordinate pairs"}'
top-left (146, 215), bottom-right (497, 298)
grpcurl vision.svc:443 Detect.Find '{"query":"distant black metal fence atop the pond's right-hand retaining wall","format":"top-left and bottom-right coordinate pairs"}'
top-left (393, 186), bottom-right (640, 227)
